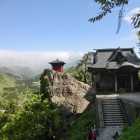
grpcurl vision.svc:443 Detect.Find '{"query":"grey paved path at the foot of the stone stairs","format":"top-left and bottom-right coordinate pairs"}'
top-left (96, 126), bottom-right (121, 140)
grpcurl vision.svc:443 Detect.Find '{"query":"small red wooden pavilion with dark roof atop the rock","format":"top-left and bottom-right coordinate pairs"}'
top-left (49, 58), bottom-right (66, 73)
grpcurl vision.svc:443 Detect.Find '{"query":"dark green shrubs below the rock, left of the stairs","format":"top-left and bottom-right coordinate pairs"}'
top-left (68, 111), bottom-right (96, 140)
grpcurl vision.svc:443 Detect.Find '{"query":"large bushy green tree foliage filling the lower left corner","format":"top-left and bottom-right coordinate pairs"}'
top-left (0, 71), bottom-right (60, 140)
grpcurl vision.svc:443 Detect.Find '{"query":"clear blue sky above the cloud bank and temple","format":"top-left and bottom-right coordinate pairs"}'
top-left (0, 0), bottom-right (140, 71)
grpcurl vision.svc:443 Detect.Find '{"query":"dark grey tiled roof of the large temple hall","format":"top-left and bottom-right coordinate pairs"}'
top-left (89, 48), bottom-right (140, 69)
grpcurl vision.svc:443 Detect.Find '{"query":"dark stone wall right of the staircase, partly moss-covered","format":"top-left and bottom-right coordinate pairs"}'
top-left (121, 98), bottom-right (140, 126)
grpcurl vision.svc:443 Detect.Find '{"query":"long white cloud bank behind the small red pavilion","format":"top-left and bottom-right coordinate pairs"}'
top-left (0, 49), bottom-right (84, 72)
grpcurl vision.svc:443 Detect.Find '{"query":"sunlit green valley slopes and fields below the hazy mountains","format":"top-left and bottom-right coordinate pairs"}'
top-left (0, 72), bottom-right (40, 109)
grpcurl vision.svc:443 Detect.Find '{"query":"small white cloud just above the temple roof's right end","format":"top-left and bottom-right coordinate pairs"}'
top-left (121, 28), bottom-right (140, 41)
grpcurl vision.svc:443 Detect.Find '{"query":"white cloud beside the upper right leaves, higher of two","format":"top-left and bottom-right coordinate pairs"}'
top-left (123, 7), bottom-right (140, 23)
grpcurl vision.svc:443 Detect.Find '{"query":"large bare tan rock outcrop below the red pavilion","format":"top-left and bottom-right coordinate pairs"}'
top-left (45, 69), bottom-right (95, 115)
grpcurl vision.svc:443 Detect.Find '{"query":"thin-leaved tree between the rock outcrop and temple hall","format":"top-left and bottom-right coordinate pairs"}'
top-left (76, 52), bottom-right (94, 83)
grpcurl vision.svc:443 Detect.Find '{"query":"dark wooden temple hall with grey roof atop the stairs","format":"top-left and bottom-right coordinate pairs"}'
top-left (88, 48), bottom-right (140, 92)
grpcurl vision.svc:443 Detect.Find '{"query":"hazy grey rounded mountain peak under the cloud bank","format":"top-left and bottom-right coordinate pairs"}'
top-left (17, 67), bottom-right (36, 79)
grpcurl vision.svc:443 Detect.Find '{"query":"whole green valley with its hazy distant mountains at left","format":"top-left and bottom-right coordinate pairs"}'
top-left (0, 67), bottom-right (40, 110)
